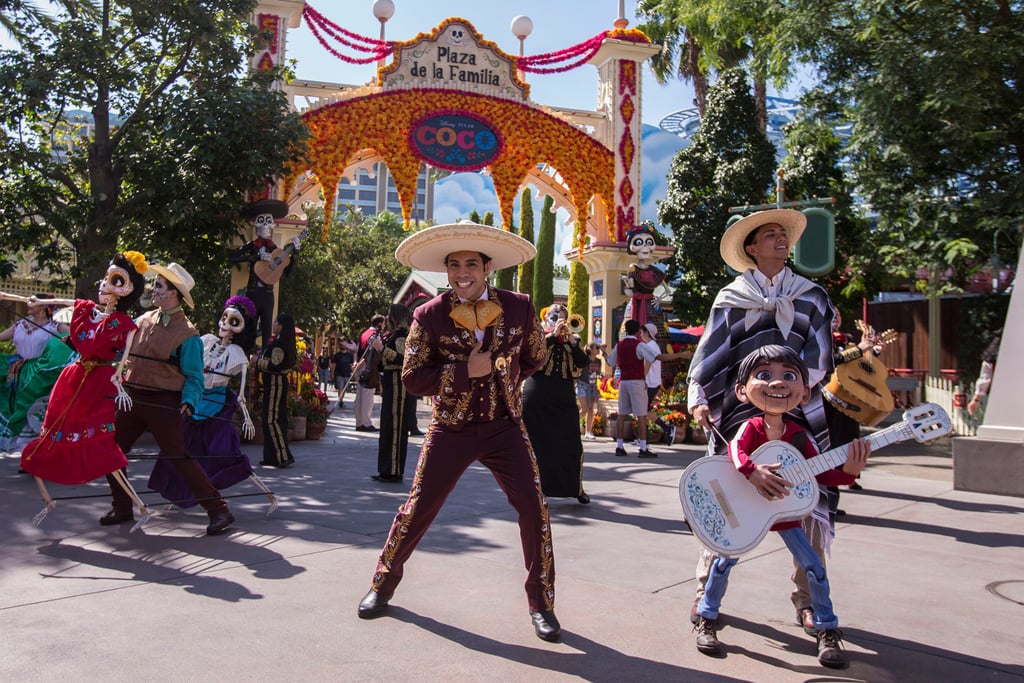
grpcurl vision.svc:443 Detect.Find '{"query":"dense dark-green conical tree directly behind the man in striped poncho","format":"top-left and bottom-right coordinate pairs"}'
top-left (657, 70), bottom-right (775, 323)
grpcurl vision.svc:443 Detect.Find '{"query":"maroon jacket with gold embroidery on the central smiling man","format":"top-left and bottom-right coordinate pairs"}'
top-left (401, 285), bottom-right (545, 429)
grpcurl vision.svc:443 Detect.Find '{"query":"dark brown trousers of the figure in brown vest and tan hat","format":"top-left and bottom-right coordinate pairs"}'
top-left (106, 388), bottom-right (227, 515)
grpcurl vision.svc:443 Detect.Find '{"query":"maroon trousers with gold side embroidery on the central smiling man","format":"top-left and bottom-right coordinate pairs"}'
top-left (373, 418), bottom-right (555, 610)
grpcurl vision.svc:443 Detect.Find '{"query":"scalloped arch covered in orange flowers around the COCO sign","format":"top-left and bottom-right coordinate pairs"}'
top-left (285, 90), bottom-right (615, 240)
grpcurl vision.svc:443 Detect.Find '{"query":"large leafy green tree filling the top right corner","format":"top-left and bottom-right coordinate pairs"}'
top-left (786, 0), bottom-right (1024, 293)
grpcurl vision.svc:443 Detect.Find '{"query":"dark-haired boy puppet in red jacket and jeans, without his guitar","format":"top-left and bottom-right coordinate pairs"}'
top-left (694, 344), bottom-right (870, 669)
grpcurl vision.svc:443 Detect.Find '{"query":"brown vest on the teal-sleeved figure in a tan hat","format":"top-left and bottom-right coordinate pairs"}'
top-left (125, 308), bottom-right (199, 391)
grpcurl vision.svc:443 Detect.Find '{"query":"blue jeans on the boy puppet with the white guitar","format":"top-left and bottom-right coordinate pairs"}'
top-left (697, 526), bottom-right (839, 631)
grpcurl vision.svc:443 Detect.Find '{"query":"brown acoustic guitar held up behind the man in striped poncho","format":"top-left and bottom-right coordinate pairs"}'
top-left (821, 321), bottom-right (897, 427)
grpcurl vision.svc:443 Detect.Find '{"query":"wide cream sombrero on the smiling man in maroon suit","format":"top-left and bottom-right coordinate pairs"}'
top-left (394, 220), bottom-right (537, 272)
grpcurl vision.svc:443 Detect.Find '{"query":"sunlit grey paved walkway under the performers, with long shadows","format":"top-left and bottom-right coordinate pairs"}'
top-left (0, 393), bottom-right (1024, 683)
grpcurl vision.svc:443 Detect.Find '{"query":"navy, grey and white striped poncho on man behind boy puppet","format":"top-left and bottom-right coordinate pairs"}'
top-left (687, 268), bottom-right (833, 453)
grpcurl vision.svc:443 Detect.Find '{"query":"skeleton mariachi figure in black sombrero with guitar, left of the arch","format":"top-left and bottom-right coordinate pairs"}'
top-left (230, 200), bottom-right (300, 346)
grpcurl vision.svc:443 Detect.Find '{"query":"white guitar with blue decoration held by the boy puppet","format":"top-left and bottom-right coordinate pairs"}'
top-left (679, 403), bottom-right (952, 557)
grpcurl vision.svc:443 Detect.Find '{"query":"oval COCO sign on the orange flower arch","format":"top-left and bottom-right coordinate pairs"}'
top-left (409, 113), bottom-right (502, 171)
